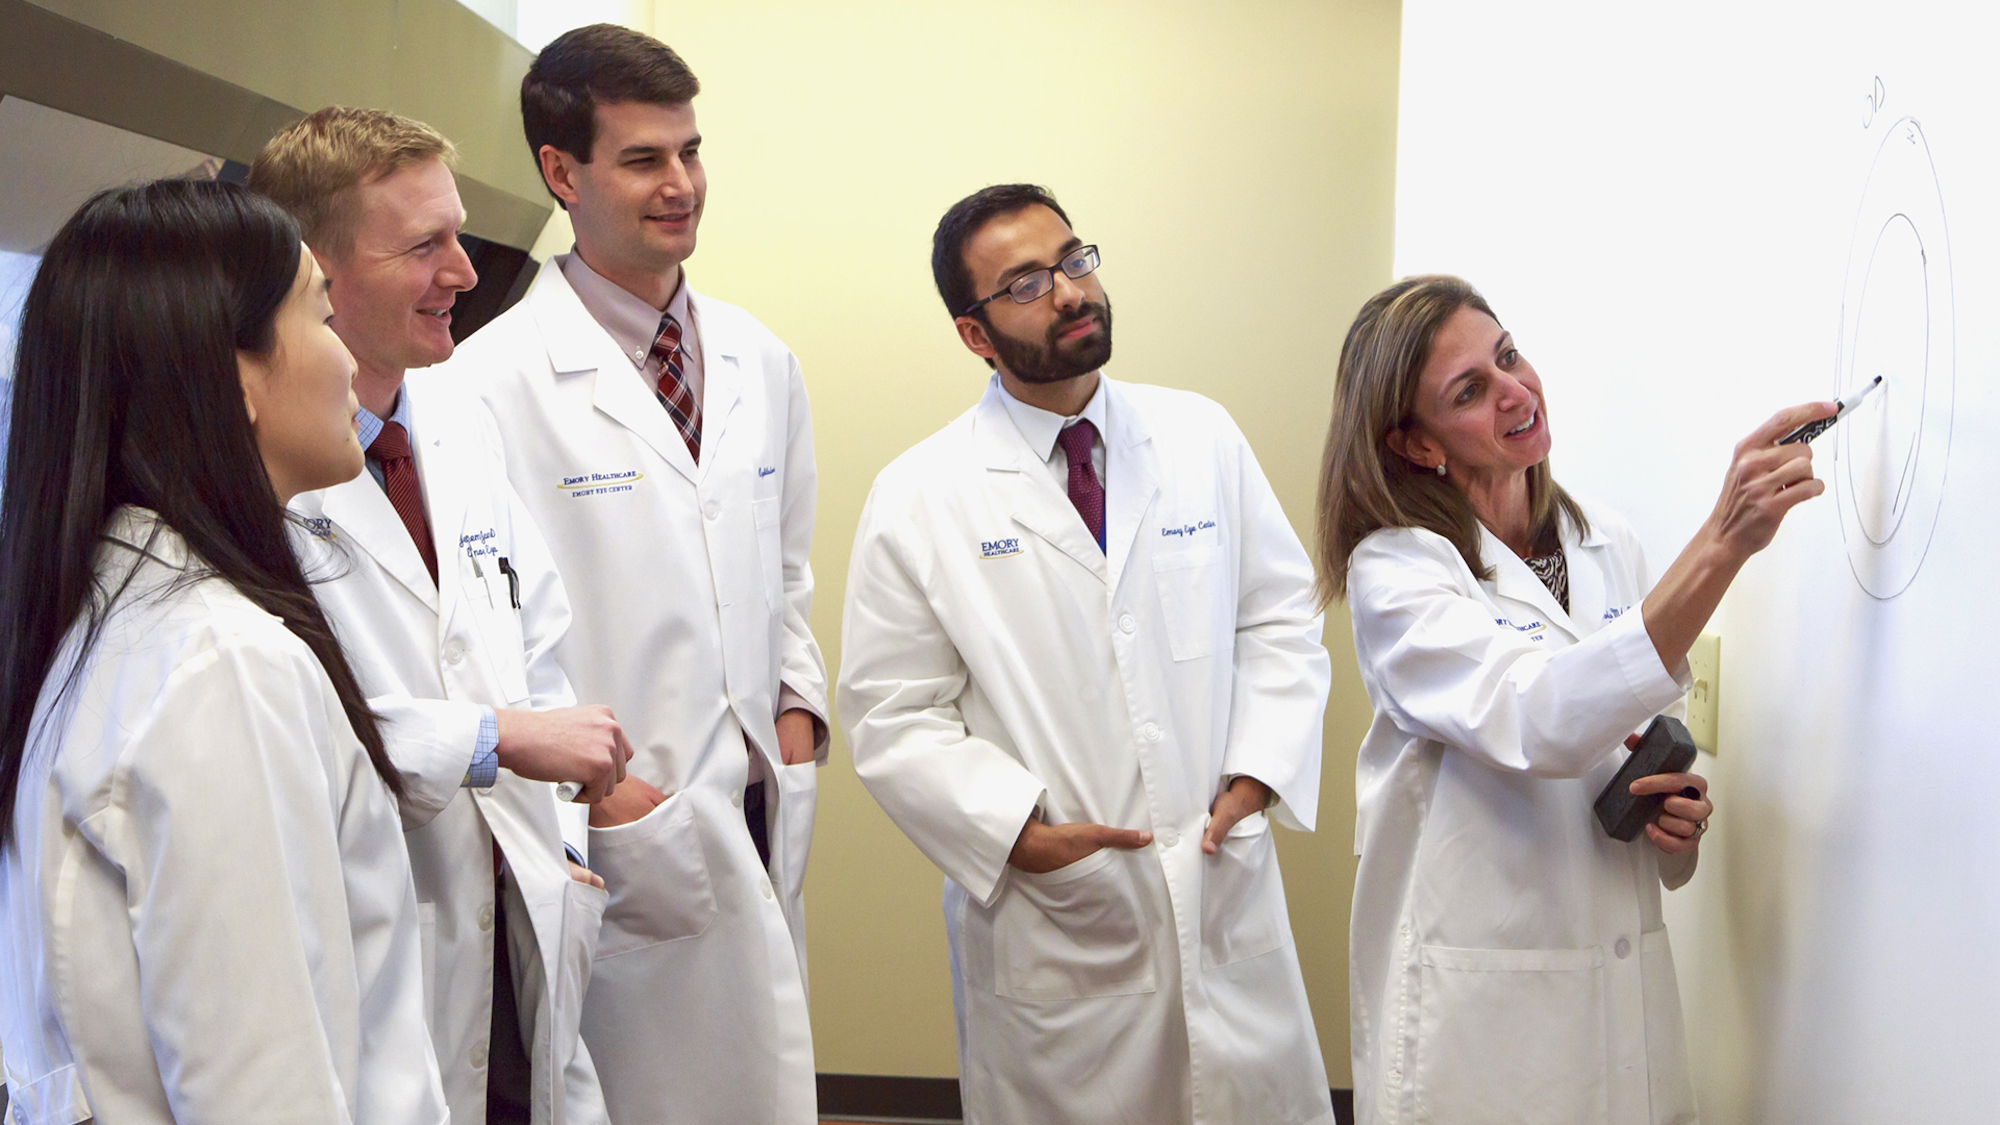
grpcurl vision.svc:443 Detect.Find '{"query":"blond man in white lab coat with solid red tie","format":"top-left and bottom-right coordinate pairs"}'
top-left (250, 106), bottom-right (630, 1125)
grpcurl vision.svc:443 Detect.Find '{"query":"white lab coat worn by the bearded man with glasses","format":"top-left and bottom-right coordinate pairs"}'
top-left (840, 378), bottom-right (1332, 1125)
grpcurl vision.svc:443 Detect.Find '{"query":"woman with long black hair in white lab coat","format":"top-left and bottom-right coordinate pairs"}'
top-left (0, 180), bottom-right (444, 1125)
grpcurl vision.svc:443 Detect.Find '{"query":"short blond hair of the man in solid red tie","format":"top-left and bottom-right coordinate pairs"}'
top-left (250, 106), bottom-right (458, 254)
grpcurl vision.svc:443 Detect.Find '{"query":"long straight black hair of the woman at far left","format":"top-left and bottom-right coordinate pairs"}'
top-left (0, 180), bottom-right (402, 845)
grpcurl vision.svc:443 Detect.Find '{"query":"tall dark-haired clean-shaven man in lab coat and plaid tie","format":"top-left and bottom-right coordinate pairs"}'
top-left (450, 24), bottom-right (828, 1125)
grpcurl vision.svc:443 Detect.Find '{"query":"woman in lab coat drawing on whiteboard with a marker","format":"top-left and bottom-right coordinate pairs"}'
top-left (1318, 276), bottom-right (1832, 1125)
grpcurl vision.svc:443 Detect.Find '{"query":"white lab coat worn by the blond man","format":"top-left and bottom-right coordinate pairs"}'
top-left (292, 372), bottom-right (606, 1125)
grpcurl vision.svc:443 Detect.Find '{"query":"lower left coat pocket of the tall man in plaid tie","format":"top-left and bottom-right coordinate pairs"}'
top-left (590, 791), bottom-right (716, 961)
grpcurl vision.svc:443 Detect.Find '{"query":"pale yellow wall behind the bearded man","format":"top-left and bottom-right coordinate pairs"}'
top-left (600, 0), bottom-right (1400, 1085)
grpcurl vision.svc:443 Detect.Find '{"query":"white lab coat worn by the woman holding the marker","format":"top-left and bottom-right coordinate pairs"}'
top-left (1348, 504), bottom-right (1694, 1125)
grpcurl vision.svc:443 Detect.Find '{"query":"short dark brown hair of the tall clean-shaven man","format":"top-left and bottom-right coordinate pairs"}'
top-left (520, 24), bottom-right (702, 194)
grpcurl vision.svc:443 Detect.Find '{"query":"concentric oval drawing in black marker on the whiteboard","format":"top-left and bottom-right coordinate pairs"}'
top-left (1832, 118), bottom-right (1956, 599)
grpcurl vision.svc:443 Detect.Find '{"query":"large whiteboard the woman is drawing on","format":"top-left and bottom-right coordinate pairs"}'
top-left (1396, 0), bottom-right (2000, 1125)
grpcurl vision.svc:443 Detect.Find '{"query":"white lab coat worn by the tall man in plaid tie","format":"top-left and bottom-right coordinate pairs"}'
top-left (446, 260), bottom-right (826, 1125)
